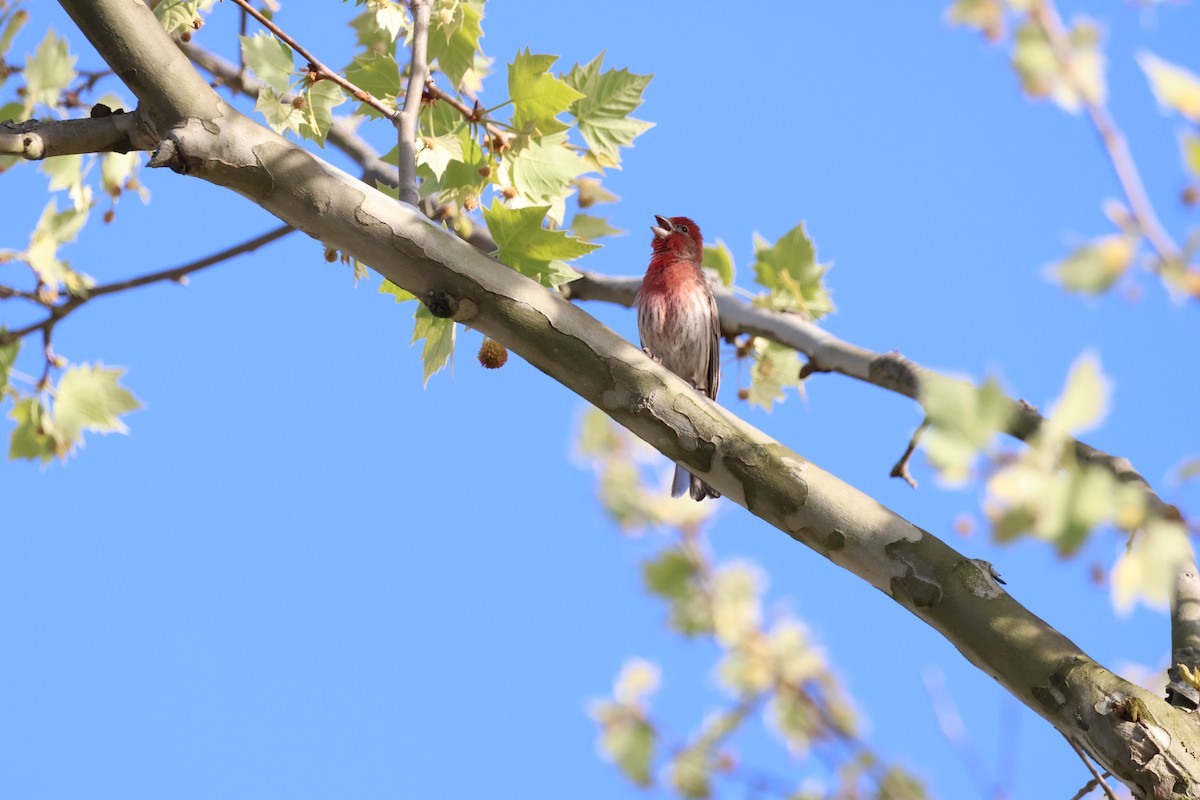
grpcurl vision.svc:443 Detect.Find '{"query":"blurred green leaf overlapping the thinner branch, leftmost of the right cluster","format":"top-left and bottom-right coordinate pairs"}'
top-left (920, 375), bottom-right (1012, 483)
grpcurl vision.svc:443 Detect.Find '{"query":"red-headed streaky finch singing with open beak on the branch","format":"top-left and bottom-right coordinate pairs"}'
top-left (637, 215), bottom-right (721, 500)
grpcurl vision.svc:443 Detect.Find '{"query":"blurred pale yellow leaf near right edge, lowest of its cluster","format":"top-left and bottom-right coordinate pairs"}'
top-left (1112, 518), bottom-right (1193, 614)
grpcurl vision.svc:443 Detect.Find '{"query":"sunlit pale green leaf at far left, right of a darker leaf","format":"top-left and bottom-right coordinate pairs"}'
top-left (54, 363), bottom-right (142, 450)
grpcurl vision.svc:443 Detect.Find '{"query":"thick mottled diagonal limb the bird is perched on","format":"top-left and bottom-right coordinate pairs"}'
top-left (54, 0), bottom-right (1200, 798)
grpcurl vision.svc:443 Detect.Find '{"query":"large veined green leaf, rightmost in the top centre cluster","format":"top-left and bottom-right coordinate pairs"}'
top-left (564, 53), bottom-right (654, 167)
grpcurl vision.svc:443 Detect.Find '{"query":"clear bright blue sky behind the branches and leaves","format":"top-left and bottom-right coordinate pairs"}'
top-left (0, 0), bottom-right (1200, 800)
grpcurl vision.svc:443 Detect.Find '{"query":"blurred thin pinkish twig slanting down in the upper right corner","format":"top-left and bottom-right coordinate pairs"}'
top-left (1030, 0), bottom-right (1180, 264)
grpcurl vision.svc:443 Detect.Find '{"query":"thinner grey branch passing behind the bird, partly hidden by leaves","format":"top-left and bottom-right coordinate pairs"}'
top-left (563, 272), bottom-right (1181, 527)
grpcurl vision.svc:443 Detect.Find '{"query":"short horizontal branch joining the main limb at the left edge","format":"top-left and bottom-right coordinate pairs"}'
top-left (0, 107), bottom-right (155, 161)
